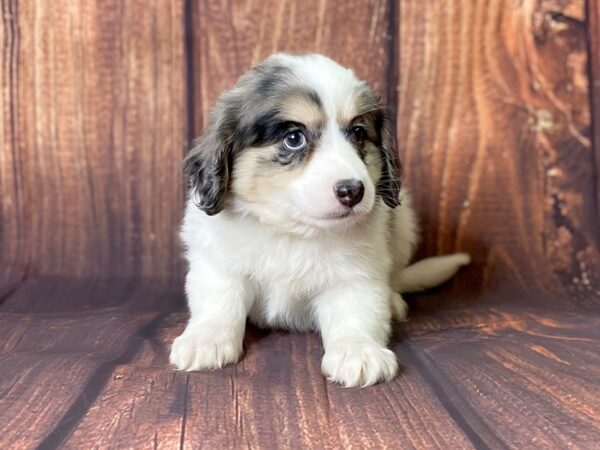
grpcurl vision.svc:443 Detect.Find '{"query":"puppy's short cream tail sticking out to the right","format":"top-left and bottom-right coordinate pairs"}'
top-left (393, 253), bottom-right (471, 294)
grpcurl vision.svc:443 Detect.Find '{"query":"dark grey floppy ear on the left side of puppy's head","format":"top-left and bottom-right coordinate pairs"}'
top-left (183, 108), bottom-right (235, 216)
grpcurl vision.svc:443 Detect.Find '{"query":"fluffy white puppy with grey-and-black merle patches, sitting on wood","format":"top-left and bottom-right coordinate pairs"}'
top-left (170, 54), bottom-right (469, 386)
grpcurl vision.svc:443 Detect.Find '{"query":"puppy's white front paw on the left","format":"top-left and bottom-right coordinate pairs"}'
top-left (169, 325), bottom-right (243, 372)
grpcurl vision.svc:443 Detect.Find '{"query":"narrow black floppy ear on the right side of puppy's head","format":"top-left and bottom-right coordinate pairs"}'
top-left (376, 113), bottom-right (402, 208)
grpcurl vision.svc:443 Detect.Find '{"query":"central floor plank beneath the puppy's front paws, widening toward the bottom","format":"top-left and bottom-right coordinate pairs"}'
top-left (63, 314), bottom-right (471, 449)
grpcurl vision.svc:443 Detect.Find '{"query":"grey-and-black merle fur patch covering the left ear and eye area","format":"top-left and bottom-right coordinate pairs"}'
top-left (183, 60), bottom-right (321, 215)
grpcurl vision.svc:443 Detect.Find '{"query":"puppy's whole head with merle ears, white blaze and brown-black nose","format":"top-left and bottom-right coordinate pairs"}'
top-left (185, 54), bottom-right (400, 229)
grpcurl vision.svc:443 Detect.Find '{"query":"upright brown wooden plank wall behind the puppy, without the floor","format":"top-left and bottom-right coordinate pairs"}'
top-left (0, 0), bottom-right (599, 298)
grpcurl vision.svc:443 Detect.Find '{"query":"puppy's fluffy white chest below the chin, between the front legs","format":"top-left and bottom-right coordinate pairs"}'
top-left (182, 202), bottom-right (390, 330)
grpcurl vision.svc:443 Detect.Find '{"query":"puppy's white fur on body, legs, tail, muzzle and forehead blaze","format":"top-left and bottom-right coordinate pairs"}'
top-left (171, 55), bottom-right (466, 386)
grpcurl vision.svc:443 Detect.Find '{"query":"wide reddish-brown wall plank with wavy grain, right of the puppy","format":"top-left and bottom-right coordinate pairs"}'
top-left (398, 0), bottom-right (599, 308)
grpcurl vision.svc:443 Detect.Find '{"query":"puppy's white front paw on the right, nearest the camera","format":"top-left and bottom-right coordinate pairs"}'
top-left (321, 341), bottom-right (398, 387)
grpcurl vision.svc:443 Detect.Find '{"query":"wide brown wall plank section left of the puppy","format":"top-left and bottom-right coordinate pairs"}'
top-left (1, 0), bottom-right (187, 278)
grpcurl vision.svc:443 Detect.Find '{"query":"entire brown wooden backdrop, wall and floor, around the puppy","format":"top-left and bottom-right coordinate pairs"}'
top-left (0, 0), bottom-right (600, 448)
